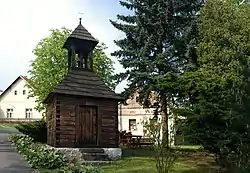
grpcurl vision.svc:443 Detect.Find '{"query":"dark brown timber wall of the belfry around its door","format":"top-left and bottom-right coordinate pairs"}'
top-left (49, 95), bottom-right (119, 147)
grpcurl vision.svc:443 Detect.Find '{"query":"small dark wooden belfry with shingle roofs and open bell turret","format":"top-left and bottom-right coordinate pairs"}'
top-left (44, 20), bottom-right (121, 148)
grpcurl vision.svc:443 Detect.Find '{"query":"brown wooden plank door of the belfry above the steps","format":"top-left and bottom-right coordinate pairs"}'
top-left (77, 106), bottom-right (98, 147)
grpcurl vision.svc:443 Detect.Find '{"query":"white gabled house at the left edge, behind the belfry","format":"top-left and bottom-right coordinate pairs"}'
top-left (0, 76), bottom-right (42, 119)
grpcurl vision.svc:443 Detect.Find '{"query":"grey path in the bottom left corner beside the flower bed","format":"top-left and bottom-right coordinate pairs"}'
top-left (0, 129), bottom-right (34, 173)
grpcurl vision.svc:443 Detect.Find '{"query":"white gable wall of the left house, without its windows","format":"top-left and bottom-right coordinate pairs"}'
top-left (0, 79), bottom-right (42, 118)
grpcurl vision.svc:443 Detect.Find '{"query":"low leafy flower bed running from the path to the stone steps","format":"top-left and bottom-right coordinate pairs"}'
top-left (9, 134), bottom-right (101, 173)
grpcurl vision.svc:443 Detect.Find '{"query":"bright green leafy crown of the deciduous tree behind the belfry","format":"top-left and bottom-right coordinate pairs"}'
top-left (28, 28), bottom-right (115, 111)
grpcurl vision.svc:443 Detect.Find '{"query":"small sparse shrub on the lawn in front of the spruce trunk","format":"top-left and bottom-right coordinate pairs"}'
top-left (143, 119), bottom-right (178, 173)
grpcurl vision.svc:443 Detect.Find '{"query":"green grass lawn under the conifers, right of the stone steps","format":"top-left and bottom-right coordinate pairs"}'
top-left (101, 149), bottom-right (217, 173)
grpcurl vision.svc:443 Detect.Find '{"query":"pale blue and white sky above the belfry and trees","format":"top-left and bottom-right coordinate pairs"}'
top-left (0, 0), bottom-right (129, 93)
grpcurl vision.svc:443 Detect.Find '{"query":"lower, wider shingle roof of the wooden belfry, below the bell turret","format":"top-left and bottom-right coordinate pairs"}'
top-left (44, 69), bottom-right (122, 103)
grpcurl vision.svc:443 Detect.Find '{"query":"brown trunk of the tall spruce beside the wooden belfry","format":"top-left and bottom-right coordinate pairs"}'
top-left (161, 94), bottom-right (169, 148)
